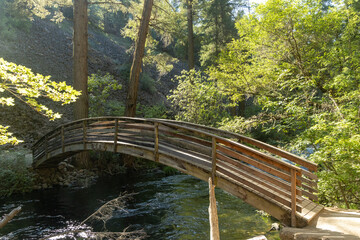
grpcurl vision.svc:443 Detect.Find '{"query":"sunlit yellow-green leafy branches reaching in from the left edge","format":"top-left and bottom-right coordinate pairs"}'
top-left (0, 58), bottom-right (80, 145)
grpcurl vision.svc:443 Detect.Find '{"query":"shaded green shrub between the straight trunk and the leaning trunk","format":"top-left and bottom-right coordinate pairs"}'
top-left (88, 73), bottom-right (122, 117)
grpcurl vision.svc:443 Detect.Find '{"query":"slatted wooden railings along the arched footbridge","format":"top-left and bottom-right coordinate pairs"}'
top-left (33, 117), bottom-right (317, 223)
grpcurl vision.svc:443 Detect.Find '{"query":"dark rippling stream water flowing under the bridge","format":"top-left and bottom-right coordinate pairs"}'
top-left (0, 170), bottom-right (279, 240)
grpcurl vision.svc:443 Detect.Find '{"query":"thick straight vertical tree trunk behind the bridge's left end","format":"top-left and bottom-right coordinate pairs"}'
top-left (73, 0), bottom-right (90, 168)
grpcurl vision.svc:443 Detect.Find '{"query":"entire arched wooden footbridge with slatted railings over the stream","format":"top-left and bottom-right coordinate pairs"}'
top-left (33, 117), bottom-right (323, 227)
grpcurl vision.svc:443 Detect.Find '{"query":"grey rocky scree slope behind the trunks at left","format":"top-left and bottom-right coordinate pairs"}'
top-left (0, 19), bottom-right (186, 146)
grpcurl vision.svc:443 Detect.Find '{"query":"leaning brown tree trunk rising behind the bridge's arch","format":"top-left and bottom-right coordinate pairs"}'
top-left (125, 0), bottom-right (154, 117)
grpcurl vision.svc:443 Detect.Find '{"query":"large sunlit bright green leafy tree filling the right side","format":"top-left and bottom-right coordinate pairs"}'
top-left (209, 0), bottom-right (360, 208)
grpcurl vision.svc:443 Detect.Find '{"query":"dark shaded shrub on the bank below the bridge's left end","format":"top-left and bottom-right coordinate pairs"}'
top-left (0, 149), bottom-right (34, 196)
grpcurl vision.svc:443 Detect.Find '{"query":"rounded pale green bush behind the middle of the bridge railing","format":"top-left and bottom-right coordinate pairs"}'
top-left (168, 70), bottom-right (228, 125)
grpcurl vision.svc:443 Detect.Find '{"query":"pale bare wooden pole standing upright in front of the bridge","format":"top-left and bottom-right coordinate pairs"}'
top-left (209, 177), bottom-right (220, 240)
